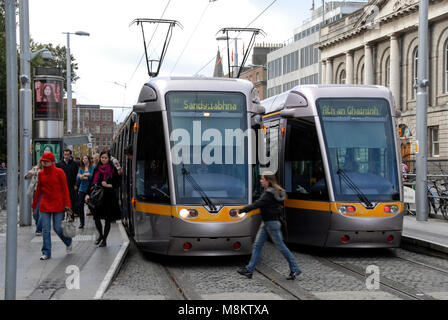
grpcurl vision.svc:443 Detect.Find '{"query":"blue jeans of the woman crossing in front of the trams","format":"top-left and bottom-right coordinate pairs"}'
top-left (246, 220), bottom-right (300, 272)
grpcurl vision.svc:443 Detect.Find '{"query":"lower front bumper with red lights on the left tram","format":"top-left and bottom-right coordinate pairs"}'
top-left (167, 237), bottom-right (253, 256)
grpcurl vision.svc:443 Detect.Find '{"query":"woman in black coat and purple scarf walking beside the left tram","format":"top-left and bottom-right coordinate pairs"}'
top-left (85, 151), bottom-right (121, 247)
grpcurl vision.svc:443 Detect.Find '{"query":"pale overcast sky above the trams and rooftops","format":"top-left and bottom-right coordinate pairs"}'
top-left (29, 0), bottom-right (322, 121)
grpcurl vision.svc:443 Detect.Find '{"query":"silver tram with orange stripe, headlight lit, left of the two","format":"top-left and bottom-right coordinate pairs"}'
top-left (112, 77), bottom-right (262, 256)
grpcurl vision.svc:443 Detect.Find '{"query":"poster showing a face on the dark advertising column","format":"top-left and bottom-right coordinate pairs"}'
top-left (34, 77), bottom-right (64, 120)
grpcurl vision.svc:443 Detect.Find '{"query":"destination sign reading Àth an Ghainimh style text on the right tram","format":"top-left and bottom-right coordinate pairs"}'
top-left (318, 99), bottom-right (388, 117)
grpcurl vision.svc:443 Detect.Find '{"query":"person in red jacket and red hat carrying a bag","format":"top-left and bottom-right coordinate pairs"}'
top-left (32, 152), bottom-right (72, 260)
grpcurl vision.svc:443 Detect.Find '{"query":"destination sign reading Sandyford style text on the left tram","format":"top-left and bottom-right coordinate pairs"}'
top-left (167, 92), bottom-right (245, 113)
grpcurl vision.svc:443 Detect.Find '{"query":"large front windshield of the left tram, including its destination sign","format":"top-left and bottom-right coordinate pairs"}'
top-left (166, 92), bottom-right (248, 205)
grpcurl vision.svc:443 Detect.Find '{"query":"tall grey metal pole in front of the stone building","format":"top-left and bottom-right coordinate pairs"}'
top-left (415, 0), bottom-right (429, 221)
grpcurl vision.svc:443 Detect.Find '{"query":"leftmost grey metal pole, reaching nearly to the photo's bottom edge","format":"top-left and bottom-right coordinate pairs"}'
top-left (5, 0), bottom-right (19, 300)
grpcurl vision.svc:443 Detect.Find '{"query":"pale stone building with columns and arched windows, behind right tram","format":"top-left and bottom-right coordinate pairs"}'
top-left (319, 0), bottom-right (448, 173)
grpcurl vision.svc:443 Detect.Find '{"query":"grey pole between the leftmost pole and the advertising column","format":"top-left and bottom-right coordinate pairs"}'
top-left (19, 0), bottom-right (32, 226)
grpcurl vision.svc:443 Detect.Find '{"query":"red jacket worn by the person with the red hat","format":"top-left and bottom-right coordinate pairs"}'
top-left (32, 165), bottom-right (71, 213)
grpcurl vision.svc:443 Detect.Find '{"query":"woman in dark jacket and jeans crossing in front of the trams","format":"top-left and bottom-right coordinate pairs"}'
top-left (238, 173), bottom-right (302, 280)
